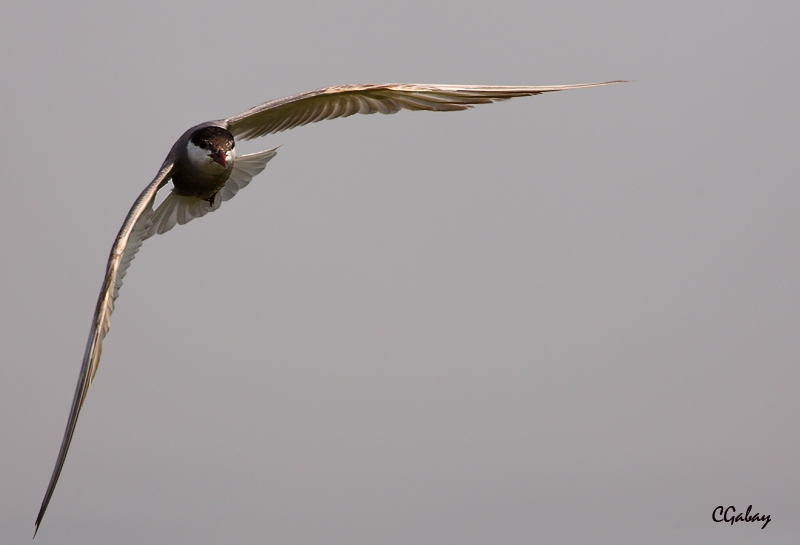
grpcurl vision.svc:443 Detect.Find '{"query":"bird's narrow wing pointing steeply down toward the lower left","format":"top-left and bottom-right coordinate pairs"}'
top-left (33, 160), bottom-right (173, 537)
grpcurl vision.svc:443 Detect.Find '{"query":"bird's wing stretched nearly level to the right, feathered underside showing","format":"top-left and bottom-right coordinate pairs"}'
top-left (225, 81), bottom-right (622, 140)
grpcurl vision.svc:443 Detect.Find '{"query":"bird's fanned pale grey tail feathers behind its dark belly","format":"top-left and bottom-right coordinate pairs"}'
top-left (144, 148), bottom-right (278, 239)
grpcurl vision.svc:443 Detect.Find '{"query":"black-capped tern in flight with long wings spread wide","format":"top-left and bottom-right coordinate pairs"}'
top-left (33, 80), bottom-right (624, 537)
